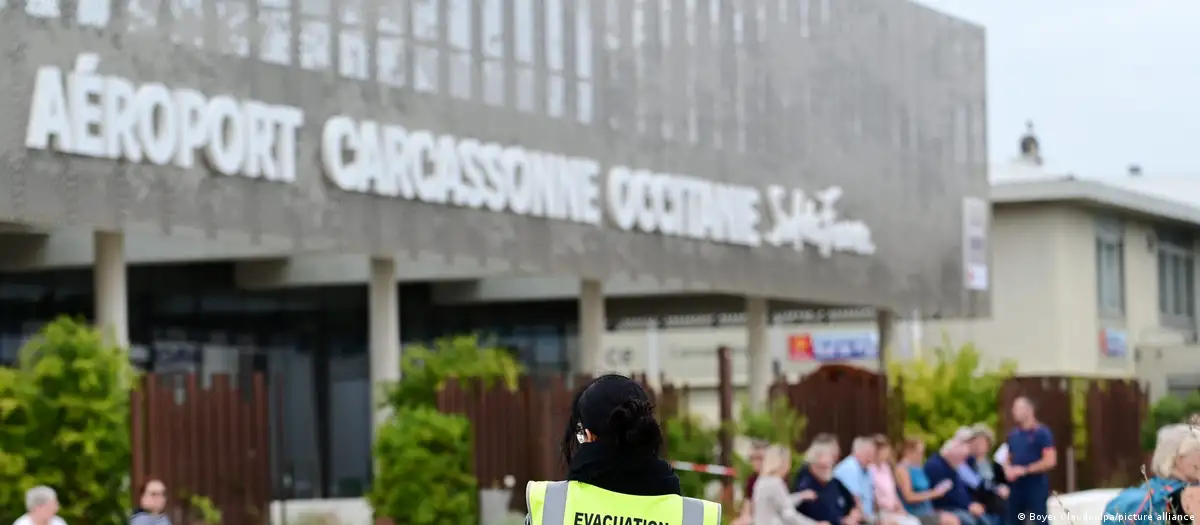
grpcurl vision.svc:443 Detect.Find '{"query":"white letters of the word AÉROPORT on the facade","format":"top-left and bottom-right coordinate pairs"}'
top-left (25, 54), bottom-right (304, 182)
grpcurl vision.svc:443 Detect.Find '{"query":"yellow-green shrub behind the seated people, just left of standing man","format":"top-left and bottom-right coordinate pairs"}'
top-left (888, 342), bottom-right (1016, 449)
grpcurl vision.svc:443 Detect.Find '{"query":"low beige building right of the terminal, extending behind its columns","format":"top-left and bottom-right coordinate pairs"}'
top-left (597, 168), bottom-right (1200, 418)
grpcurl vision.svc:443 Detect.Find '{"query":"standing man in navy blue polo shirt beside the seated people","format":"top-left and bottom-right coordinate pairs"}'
top-left (1003, 396), bottom-right (1058, 525)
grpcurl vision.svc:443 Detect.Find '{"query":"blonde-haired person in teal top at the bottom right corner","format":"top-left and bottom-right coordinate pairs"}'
top-left (1103, 423), bottom-right (1200, 525)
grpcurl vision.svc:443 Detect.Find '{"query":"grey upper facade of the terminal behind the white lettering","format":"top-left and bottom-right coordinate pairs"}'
top-left (0, 0), bottom-right (986, 314)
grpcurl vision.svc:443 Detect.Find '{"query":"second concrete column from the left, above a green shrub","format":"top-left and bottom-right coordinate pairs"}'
top-left (367, 258), bottom-right (400, 435)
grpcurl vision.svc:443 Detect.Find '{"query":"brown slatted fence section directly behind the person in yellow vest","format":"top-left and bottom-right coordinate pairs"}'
top-left (438, 375), bottom-right (679, 509)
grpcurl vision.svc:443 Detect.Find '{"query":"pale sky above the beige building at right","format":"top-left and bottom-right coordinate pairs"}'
top-left (918, 0), bottom-right (1200, 177)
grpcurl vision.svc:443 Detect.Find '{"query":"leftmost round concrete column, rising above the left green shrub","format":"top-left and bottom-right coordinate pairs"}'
top-left (92, 231), bottom-right (130, 348)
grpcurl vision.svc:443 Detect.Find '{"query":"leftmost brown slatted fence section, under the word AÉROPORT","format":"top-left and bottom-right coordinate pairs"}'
top-left (131, 374), bottom-right (271, 525)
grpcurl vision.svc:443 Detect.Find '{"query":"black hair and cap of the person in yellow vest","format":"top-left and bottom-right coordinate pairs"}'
top-left (562, 374), bottom-right (662, 464)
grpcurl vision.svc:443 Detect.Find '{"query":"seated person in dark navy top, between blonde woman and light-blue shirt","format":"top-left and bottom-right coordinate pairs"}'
top-left (792, 441), bottom-right (863, 525)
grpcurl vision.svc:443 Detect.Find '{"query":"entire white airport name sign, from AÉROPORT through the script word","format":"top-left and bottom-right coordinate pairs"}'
top-left (18, 53), bottom-right (875, 257)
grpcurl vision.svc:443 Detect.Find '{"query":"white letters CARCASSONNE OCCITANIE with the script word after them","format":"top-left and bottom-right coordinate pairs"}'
top-left (320, 115), bottom-right (875, 257)
